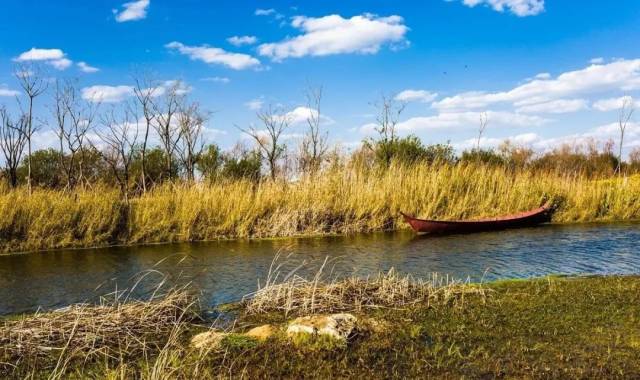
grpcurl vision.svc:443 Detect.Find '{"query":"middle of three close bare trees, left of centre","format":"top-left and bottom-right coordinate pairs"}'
top-left (151, 81), bottom-right (184, 179)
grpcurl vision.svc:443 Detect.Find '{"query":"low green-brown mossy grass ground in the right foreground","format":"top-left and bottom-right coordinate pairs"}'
top-left (13, 276), bottom-right (640, 379)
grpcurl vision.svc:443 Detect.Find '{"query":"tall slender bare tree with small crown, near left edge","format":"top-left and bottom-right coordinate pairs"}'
top-left (14, 64), bottom-right (48, 194)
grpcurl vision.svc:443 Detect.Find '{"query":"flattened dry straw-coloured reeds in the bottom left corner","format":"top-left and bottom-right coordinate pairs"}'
top-left (0, 288), bottom-right (196, 378)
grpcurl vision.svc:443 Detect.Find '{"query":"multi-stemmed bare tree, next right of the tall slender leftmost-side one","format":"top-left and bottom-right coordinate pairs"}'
top-left (54, 81), bottom-right (100, 189)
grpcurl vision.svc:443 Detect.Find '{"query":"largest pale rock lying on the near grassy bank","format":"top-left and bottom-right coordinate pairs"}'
top-left (287, 313), bottom-right (357, 341)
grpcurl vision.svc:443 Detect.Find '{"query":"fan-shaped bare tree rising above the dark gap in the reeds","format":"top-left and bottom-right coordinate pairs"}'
top-left (96, 107), bottom-right (138, 203)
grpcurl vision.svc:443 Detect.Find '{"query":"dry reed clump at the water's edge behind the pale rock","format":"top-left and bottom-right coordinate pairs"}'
top-left (244, 255), bottom-right (487, 316)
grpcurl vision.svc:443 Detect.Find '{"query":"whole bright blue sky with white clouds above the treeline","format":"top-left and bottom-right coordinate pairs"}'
top-left (0, 0), bottom-right (640, 154)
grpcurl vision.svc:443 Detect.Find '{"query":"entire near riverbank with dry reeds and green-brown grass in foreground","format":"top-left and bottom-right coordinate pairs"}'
top-left (0, 274), bottom-right (640, 379)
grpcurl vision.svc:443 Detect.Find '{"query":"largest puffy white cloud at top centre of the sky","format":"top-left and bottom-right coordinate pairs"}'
top-left (258, 14), bottom-right (409, 61)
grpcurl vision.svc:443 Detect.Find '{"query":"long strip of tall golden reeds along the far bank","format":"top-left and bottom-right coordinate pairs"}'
top-left (0, 164), bottom-right (640, 252)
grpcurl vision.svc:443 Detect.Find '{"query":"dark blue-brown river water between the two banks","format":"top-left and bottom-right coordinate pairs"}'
top-left (0, 224), bottom-right (640, 314)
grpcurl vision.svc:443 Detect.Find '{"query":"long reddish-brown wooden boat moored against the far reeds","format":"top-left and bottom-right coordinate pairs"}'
top-left (400, 204), bottom-right (554, 234)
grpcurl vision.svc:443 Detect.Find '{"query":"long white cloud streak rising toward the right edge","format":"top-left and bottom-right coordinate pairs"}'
top-left (432, 59), bottom-right (640, 110)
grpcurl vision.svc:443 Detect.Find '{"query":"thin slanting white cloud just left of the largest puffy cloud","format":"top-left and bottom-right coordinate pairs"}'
top-left (165, 41), bottom-right (260, 70)
